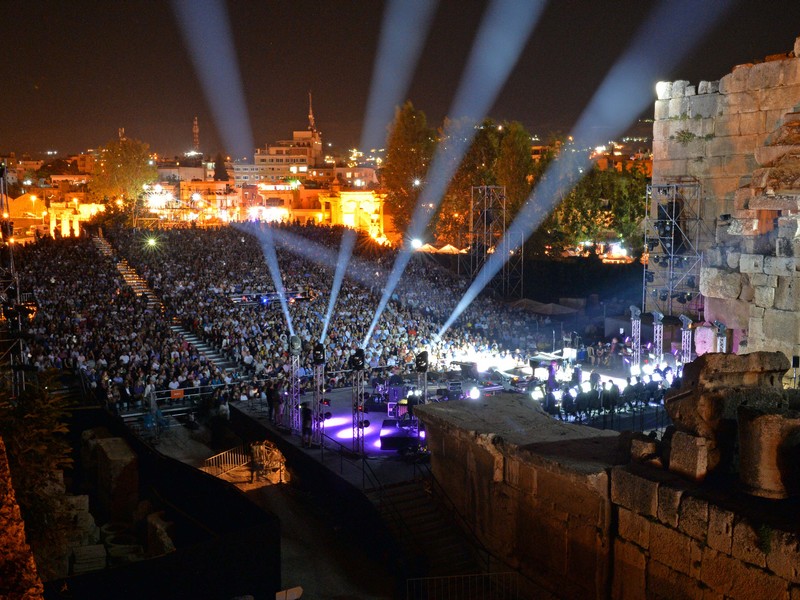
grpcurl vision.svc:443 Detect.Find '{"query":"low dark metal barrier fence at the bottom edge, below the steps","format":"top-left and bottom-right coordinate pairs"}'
top-left (406, 573), bottom-right (520, 600)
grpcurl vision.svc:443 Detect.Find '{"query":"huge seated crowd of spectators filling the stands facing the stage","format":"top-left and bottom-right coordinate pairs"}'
top-left (9, 223), bottom-right (564, 414)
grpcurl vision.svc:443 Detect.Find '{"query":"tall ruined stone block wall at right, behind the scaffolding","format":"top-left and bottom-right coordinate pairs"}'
top-left (653, 38), bottom-right (800, 357)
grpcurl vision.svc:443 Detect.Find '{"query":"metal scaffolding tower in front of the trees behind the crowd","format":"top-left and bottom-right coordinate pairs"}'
top-left (459, 185), bottom-right (525, 300)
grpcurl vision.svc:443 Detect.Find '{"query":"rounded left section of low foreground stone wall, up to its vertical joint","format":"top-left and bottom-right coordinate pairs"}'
top-left (425, 417), bottom-right (613, 598)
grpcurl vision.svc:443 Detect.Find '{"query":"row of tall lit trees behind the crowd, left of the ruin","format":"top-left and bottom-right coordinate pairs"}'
top-left (381, 102), bottom-right (647, 256)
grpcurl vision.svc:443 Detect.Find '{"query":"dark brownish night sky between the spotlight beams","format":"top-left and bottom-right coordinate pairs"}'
top-left (0, 0), bottom-right (800, 156)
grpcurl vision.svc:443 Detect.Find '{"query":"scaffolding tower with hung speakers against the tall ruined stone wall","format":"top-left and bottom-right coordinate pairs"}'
top-left (642, 179), bottom-right (710, 315)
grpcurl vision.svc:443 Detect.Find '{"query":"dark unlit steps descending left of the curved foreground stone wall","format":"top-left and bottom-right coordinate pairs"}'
top-left (367, 481), bottom-right (483, 577)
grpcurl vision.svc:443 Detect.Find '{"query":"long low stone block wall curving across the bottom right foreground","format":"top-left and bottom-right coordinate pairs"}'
top-left (424, 406), bottom-right (800, 600)
